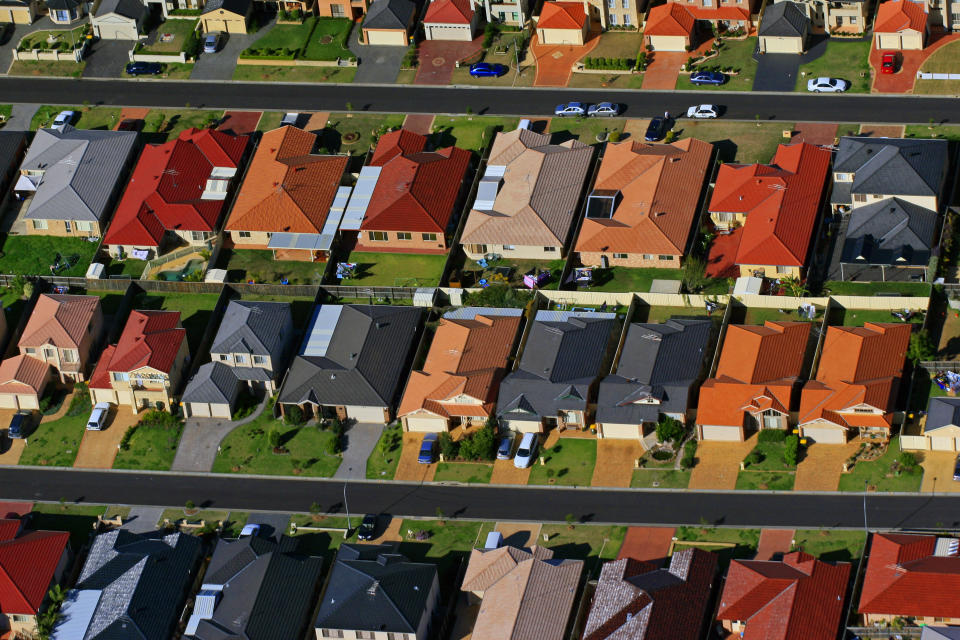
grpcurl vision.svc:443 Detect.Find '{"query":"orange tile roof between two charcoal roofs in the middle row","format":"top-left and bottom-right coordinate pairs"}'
top-left (397, 315), bottom-right (520, 418)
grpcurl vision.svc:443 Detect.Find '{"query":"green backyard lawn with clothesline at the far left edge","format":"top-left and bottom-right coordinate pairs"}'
top-left (0, 236), bottom-right (97, 277)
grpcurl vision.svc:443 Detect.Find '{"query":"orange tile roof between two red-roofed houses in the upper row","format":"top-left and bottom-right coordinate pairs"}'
top-left (224, 127), bottom-right (349, 233)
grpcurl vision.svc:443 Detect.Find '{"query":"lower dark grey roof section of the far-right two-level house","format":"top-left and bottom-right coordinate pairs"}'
top-left (840, 198), bottom-right (938, 266)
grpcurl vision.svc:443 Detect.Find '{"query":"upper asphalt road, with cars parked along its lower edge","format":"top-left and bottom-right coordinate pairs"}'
top-left (0, 78), bottom-right (960, 124)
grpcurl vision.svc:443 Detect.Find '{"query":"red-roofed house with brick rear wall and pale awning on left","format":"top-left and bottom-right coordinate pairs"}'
top-left (347, 129), bottom-right (470, 254)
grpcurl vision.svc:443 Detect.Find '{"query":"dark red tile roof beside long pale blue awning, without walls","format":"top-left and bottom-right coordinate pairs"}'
top-left (360, 129), bottom-right (470, 234)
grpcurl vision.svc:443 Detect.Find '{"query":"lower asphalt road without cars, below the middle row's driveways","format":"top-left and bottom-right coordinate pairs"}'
top-left (0, 467), bottom-right (960, 529)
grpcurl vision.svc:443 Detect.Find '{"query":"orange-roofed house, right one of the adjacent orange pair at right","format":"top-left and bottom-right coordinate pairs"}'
top-left (797, 322), bottom-right (912, 444)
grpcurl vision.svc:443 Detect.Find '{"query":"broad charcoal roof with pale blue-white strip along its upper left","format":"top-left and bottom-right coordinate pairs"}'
top-left (279, 304), bottom-right (422, 407)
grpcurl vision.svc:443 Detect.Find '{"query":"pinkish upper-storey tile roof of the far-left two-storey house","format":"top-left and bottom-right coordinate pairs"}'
top-left (17, 293), bottom-right (100, 349)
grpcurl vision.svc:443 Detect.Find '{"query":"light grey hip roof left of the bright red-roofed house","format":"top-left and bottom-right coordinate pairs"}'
top-left (21, 126), bottom-right (137, 222)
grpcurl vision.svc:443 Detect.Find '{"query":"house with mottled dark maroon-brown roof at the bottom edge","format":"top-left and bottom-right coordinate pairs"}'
top-left (582, 548), bottom-right (717, 640)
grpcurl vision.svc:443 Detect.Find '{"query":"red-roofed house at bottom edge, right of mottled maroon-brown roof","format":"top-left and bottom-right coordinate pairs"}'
top-left (717, 551), bottom-right (852, 640)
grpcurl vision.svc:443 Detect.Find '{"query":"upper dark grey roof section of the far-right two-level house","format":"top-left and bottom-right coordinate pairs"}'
top-left (831, 137), bottom-right (947, 204)
